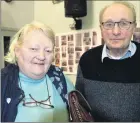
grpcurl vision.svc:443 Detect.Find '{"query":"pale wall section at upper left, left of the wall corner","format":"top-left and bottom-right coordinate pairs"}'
top-left (1, 0), bottom-right (34, 28)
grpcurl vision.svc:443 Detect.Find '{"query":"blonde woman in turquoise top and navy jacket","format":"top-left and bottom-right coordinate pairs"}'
top-left (1, 22), bottom-right (74, 122)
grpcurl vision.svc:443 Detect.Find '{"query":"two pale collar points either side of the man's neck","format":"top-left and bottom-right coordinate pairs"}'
top-left (102, 41), bottom-right (136, 62)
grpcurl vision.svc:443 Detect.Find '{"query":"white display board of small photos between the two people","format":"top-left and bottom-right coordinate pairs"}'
top-left (54, 29), bottom-right (102, 74)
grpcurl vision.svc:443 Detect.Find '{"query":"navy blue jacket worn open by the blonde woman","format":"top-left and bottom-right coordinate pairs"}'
top-left (1, 64), bottom-right (68, 122)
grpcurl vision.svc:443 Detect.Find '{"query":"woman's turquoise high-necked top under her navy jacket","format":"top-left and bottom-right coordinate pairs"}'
top-left (15, 73), bottom-right (74, 122)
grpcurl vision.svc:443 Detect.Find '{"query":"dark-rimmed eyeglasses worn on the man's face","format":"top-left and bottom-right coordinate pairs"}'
top-left (102, 21), bottom-right (135, 30)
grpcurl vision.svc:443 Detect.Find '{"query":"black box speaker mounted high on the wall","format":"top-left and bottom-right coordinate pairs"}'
top-left (64, 0), bottom-right (87, 17)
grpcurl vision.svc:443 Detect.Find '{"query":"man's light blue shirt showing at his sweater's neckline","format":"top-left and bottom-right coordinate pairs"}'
top-left (102, 41), bottom-right (137, 62)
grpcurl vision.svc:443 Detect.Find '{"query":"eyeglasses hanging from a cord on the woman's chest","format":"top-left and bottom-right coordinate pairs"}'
top-left (23, 94), bottom-right (54, 109)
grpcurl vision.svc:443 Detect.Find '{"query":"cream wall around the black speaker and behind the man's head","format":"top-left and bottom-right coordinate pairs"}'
top-left (34, 1), bottom-right (140, 82)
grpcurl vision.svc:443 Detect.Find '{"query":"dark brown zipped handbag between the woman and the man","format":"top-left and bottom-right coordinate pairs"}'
top-left (68, 90), bottom-right (94, 122)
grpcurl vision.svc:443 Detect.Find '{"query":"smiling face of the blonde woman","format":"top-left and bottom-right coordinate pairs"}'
top-left (15, 30), bottom-right (54, 79)
